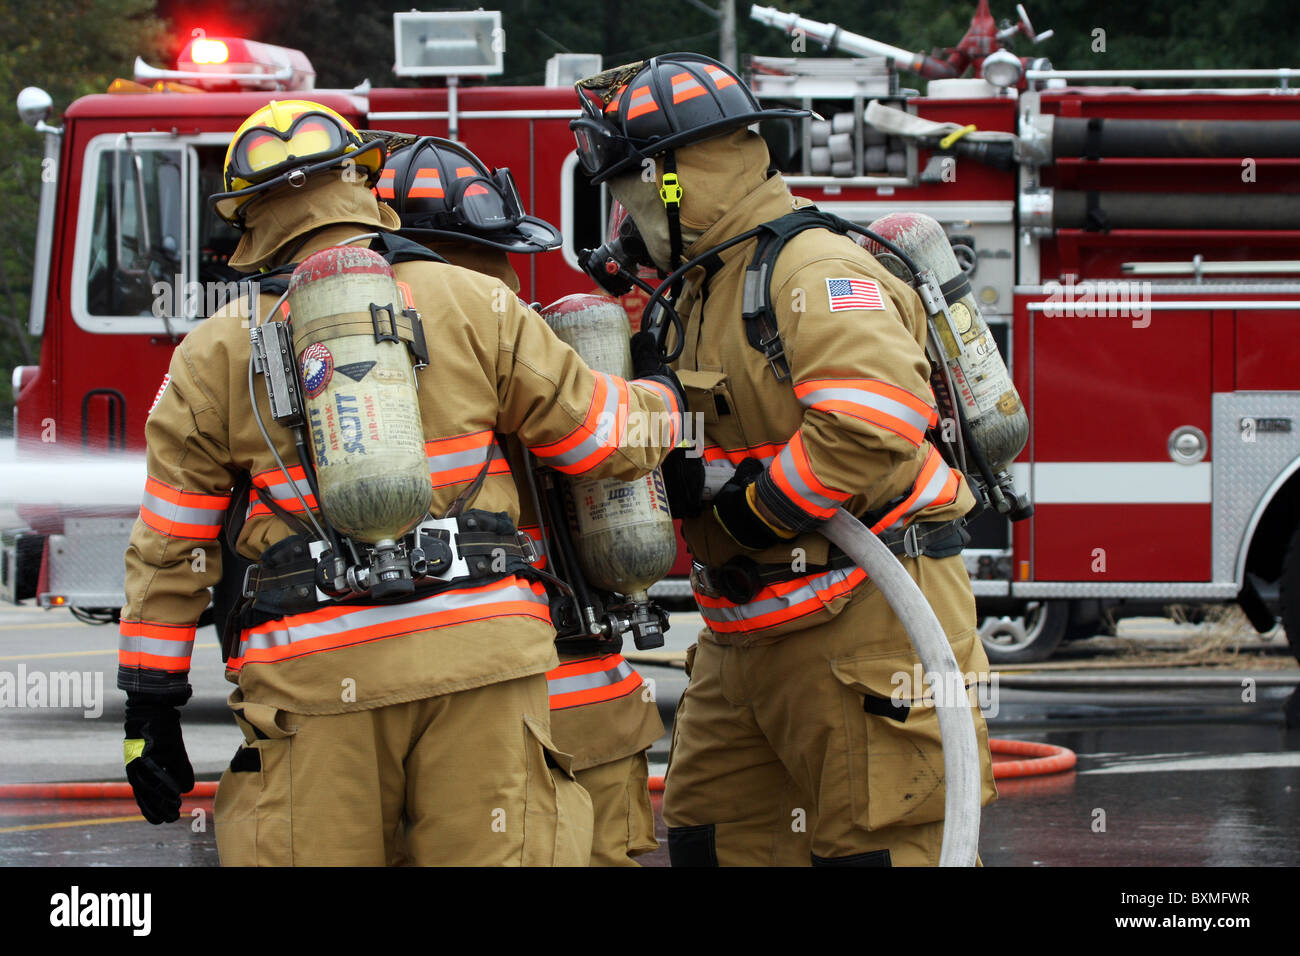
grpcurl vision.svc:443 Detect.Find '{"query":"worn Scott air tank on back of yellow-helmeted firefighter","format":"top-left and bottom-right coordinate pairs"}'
top-left (289, 246), bottom-right (433, 545)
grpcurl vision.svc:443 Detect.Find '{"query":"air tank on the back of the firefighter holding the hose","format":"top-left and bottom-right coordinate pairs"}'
top-left (858, 212), bottom-right (1032, 520)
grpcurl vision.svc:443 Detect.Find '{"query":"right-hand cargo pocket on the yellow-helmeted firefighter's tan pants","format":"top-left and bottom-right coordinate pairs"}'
top-left (521, 714), bottom-right (594, 866)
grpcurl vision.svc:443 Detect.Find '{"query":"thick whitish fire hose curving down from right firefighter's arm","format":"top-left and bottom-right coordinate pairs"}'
top-left (703, 466), bottom-right (980, 866)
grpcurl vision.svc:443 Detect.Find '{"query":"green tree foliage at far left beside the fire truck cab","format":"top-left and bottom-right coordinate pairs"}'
top-left (0, 0), bottom-right (168, 432)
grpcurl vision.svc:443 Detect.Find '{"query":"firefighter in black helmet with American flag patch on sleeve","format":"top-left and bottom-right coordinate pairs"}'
top-left (571, 53), bottom-right (995, 866)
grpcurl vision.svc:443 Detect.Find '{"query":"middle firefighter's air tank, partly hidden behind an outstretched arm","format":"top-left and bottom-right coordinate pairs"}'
top-left (541, 294), bottom-right (677, 602)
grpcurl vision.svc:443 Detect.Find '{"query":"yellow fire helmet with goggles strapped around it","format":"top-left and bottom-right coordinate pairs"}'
top-left (209, 100), bottom-right (387, 229)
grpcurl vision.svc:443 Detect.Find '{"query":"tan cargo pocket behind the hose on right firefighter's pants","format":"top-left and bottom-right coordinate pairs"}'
top-left (831, 628), bottom-right (992, 830)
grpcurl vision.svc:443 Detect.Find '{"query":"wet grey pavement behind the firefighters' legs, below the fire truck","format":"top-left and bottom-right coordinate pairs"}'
top-left (0, 607), bottom-right (1300, 866)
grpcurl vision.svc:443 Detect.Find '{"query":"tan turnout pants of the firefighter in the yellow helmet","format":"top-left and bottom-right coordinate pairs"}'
top-left (215, 674), bottom-right (592, 866)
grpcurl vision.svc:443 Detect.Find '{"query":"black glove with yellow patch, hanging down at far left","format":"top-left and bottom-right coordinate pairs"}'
top-left (122, 689), bottom-right (194, 823)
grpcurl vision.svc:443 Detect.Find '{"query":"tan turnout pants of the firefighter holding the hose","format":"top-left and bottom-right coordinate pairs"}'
top-left (663, 555), bottom-right (997, 866)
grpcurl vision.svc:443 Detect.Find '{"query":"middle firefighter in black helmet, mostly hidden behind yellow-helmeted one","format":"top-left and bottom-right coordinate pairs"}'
top-left (377, 137), bottom-right (663, 866)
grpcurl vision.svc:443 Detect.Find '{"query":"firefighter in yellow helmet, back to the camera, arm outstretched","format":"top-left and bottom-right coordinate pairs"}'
top-left (118, 100), bottom-right (679, 865)
